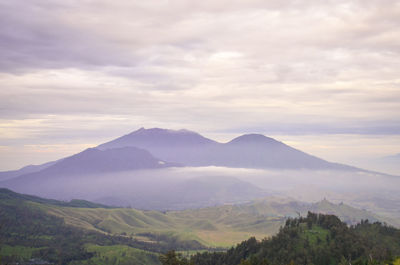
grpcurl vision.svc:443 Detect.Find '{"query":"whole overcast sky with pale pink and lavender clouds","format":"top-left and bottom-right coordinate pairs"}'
top-left (0, 0), bottom-right (400, 170)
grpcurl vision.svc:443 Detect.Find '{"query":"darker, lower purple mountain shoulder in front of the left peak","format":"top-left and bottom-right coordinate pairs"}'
top-left (0, 147), bottom-right (189, 206)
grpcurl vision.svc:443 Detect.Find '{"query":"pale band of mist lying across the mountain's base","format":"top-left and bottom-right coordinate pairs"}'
top-left (0, 166), bottom-right (400, 216)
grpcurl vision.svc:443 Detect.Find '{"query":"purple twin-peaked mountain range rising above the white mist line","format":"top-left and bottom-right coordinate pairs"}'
top-left (0, 128), bottom-right (360, 181)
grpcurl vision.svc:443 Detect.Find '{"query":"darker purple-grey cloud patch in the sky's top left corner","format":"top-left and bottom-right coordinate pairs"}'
top-left (0, 1), bottom-right (138, 73)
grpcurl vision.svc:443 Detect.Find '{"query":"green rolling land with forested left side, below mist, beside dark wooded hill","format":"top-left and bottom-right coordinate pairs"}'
top-left (0, 189), bottom-right (394, 264)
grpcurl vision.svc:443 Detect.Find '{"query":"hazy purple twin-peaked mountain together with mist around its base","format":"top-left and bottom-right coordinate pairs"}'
top-left (0, 128), bottom-right (400, 221)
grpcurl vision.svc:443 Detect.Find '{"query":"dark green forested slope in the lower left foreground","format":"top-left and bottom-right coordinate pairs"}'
top-left (0, 189), bottom-right (203, 265)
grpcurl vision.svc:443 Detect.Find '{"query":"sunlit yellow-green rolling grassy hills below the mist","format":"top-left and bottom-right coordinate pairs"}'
top-left (38, 195), bottom-right (386, 247)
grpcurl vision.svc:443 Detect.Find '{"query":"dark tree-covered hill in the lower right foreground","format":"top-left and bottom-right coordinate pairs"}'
top-left (164, 212), bottom-right (400, 265)
